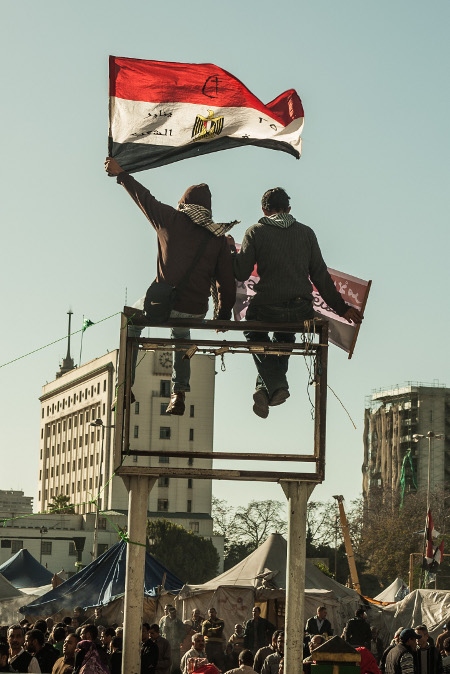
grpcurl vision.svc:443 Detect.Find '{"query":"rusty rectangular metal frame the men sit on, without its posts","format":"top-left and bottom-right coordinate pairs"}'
top-left (114, 307), bottom-right (328, 483)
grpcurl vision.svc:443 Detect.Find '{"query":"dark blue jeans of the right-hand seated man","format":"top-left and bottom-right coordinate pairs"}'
top-left (244, 299), bottom-right (314, 399)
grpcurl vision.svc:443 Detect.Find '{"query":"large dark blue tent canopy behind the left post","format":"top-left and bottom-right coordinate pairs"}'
top-left (20, 541), bottom-right (183, 616)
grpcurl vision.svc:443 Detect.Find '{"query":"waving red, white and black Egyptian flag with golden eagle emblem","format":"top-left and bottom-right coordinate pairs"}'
top-left (109, 56), bottom-right (304, 173)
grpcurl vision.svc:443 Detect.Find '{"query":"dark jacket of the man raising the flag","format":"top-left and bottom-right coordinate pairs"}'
top-left (117, 173), bottom-right (236, 320)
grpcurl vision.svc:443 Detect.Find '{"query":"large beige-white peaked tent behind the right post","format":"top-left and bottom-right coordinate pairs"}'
top-left (177, 534), bottom-right (361, 637)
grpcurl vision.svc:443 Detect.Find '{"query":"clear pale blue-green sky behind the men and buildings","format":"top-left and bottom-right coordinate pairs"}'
top-left (0, 0), bottom-right (450, 505)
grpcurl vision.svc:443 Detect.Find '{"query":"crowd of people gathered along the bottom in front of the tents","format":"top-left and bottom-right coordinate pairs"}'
top-left (0, 604), bottom-right (450, 674)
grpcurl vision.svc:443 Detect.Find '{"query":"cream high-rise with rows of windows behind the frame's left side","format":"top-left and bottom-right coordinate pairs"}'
top-left (38, 342), bottom-right (215, 537)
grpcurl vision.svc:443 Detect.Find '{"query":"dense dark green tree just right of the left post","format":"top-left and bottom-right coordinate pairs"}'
top-left (147, 519), bottom-right (219, 583)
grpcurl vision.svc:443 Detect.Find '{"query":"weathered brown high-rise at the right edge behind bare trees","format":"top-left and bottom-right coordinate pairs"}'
top-left (363, 382), bottom-right (450, 504)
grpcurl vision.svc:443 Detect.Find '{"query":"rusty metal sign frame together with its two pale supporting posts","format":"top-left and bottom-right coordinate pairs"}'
top-left (114, 307), bottom-right (328, 674)
